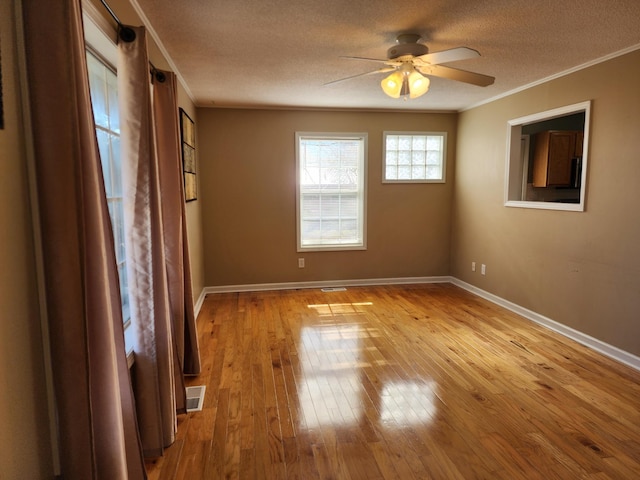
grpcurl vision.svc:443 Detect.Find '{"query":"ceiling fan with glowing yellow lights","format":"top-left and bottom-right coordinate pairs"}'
top-left (325, 33), bottom-right (495, 99)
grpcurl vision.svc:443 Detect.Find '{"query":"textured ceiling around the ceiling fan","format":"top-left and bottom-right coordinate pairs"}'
top-left (134, 0), bottom-right (640, 111)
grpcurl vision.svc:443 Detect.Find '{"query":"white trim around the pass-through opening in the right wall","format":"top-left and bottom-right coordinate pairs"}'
top-left (504, 100), bottom-right (591, 212)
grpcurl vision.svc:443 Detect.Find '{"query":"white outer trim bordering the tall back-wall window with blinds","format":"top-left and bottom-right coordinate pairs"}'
top-left (295, 132), bottom-right (369, 252)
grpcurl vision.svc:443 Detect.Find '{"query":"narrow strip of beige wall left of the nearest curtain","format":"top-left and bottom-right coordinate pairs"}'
top-left (0, 2), bottom-right (53, 480)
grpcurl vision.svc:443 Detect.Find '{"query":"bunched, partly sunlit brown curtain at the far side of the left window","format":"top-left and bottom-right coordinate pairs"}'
top-left (118, 27), bottom-right (199, 456)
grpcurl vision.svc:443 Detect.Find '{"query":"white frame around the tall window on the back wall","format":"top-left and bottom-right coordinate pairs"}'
top-left (295, 132), bottom-right (368, 252)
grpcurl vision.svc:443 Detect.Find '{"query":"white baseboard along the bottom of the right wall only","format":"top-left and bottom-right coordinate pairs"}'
top-left (451, 277), bottom-right (640, 370)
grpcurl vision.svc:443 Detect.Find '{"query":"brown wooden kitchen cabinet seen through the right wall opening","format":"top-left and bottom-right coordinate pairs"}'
top-left (533, 130), bottom-right (583, 187)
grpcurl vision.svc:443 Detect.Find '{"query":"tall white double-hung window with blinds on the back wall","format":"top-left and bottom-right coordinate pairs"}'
top-left (296, 132), bottom-right (367, 251)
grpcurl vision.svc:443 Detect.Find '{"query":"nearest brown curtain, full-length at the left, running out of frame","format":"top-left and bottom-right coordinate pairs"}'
top-left (22, 0), bottom-right (146, 480)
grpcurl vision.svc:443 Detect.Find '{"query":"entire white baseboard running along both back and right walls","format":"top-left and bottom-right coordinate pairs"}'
top-left (196, 276), bottom-right (640, 371)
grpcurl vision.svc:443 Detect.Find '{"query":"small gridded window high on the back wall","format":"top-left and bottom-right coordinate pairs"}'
top-left (382, 132), bottom-right (447, 183)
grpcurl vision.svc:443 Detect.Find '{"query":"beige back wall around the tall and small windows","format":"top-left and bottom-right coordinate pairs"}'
top-left (198, 109), bottom-right (457, 286)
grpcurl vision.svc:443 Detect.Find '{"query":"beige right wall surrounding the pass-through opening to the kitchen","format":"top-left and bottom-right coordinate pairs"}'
top-left (451, 51), bottom-right (640, 355)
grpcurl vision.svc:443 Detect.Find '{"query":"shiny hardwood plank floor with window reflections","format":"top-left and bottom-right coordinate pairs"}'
top-left (147, 284), bottom-right (640, 480)
